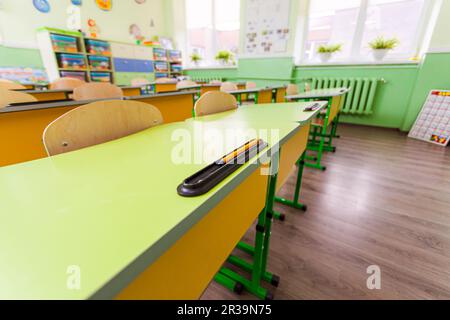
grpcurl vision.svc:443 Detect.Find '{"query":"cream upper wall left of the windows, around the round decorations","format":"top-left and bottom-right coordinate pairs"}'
top-left (0, 0), bottom-right (169, 48)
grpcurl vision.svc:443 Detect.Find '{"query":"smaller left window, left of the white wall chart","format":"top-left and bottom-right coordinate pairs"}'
top-left (186, 0), bottom-right (240, 66)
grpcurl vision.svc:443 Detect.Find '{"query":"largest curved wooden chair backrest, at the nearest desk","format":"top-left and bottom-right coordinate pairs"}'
top-left (43, 100), bottom-right (163, 156)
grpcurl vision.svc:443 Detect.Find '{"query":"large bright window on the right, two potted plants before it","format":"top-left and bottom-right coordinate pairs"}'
top-left (301, 0), bottom-right (430, 62)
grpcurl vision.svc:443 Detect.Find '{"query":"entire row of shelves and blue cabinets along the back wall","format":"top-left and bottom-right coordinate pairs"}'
top-left (37, 28), bottom-right (183, 86)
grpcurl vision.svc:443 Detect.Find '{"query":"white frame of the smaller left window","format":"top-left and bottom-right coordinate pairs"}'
top-left (184, 0), bottom-right (242, 69)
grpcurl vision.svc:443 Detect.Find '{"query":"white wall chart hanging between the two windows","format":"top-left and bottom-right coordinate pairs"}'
top-left (244, 0), bottom-right (291, 55)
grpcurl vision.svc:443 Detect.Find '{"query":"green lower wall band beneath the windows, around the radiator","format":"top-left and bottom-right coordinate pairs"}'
top-left (186, 58), bottom-right (419, 128)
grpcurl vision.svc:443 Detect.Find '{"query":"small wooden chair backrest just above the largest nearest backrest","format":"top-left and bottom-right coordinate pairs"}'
top-left (73, 82), bottom-right (123, 101)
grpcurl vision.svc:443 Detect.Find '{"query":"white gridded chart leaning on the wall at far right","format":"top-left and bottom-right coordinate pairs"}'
top-left (409, 90), bottom-right (450, 147)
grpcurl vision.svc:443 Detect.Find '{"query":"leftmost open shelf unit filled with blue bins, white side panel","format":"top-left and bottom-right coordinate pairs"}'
top-left (37, 28), bottom-right (115, 83)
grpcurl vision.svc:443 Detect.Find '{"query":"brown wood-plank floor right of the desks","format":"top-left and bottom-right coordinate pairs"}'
top-left (203, 126), bottom-right (450, 300)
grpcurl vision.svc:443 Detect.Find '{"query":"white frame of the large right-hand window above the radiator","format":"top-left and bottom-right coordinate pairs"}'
top-left (296, 0), bottom-right (436, 66)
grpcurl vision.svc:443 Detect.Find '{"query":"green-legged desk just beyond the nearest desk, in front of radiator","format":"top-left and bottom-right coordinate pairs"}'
top-left (286, 88), bottom-right (350, 171)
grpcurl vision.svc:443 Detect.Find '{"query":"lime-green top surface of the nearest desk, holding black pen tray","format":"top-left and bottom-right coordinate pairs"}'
top-left (0, 106), bottom-right (320, 299)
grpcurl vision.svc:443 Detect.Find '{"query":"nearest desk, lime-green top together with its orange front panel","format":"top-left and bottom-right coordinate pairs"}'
top-left (0, 105), bottom-right (320, 299)
